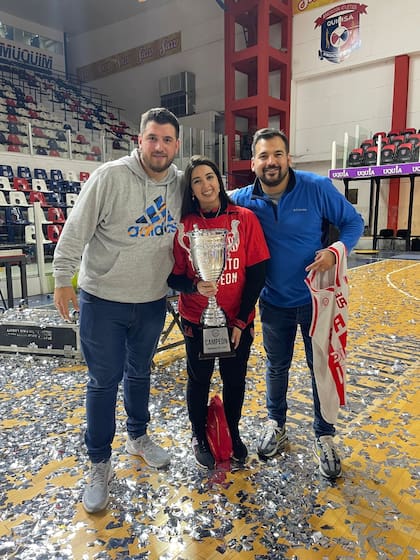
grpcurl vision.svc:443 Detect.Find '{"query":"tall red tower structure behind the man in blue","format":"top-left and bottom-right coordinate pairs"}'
top-left (225, 0), bottom-right (292, 188)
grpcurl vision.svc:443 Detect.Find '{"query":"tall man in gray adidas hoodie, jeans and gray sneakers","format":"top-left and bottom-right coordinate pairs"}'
top-left (53, 108), bottom-right (182, 513)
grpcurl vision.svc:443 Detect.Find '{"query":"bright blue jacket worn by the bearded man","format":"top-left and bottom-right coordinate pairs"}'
top-left (229, 169), bottom-right (364, 307)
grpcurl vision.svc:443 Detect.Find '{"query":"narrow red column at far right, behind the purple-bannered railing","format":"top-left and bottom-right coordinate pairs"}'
top-left (387, 55), bottom-right (410, 231)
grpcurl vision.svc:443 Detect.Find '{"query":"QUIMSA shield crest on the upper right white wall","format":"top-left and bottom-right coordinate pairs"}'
top-left (315, 2), bottom-right (367, 64)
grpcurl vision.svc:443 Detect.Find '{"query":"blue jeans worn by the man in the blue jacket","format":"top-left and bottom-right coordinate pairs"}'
top-left (260, 299), bottom-right (335, 437)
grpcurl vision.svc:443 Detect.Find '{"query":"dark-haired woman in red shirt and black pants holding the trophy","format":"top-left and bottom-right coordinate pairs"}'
top-left (168, 156), bottom-right (270, 469)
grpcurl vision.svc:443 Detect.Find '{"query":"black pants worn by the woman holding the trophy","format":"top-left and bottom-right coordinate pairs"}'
top-left (182, 319), bottom-right (254, 439)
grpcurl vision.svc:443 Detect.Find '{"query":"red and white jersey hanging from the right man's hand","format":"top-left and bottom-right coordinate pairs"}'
top-left (305, 241), bottom-right (349, 424)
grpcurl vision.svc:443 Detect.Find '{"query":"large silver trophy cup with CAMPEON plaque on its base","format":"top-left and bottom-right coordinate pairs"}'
top-left (178, 225), bottom-right (235, 359)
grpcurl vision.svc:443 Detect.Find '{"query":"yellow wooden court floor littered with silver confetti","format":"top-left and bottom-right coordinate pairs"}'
top-left (0, 259), bottom-right (420, 560)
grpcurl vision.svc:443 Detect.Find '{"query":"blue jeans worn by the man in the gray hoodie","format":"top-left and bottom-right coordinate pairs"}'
top-left (80, 290), bottom-right (166, 463)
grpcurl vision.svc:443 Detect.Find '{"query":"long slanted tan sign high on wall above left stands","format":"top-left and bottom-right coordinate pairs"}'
top-left (77, 31), bottom-right (181, 81)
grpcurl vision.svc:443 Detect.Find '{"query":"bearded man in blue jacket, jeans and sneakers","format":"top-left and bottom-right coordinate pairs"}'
top-left (229, 128), bottom-right (364, 478)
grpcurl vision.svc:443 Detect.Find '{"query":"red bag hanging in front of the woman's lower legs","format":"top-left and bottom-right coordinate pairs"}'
top-left (206, 395), bottom-right (232, 463)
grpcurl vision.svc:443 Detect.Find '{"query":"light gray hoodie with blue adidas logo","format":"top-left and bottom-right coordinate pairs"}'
top-left (53, 149), bottom-right (182, 303)
